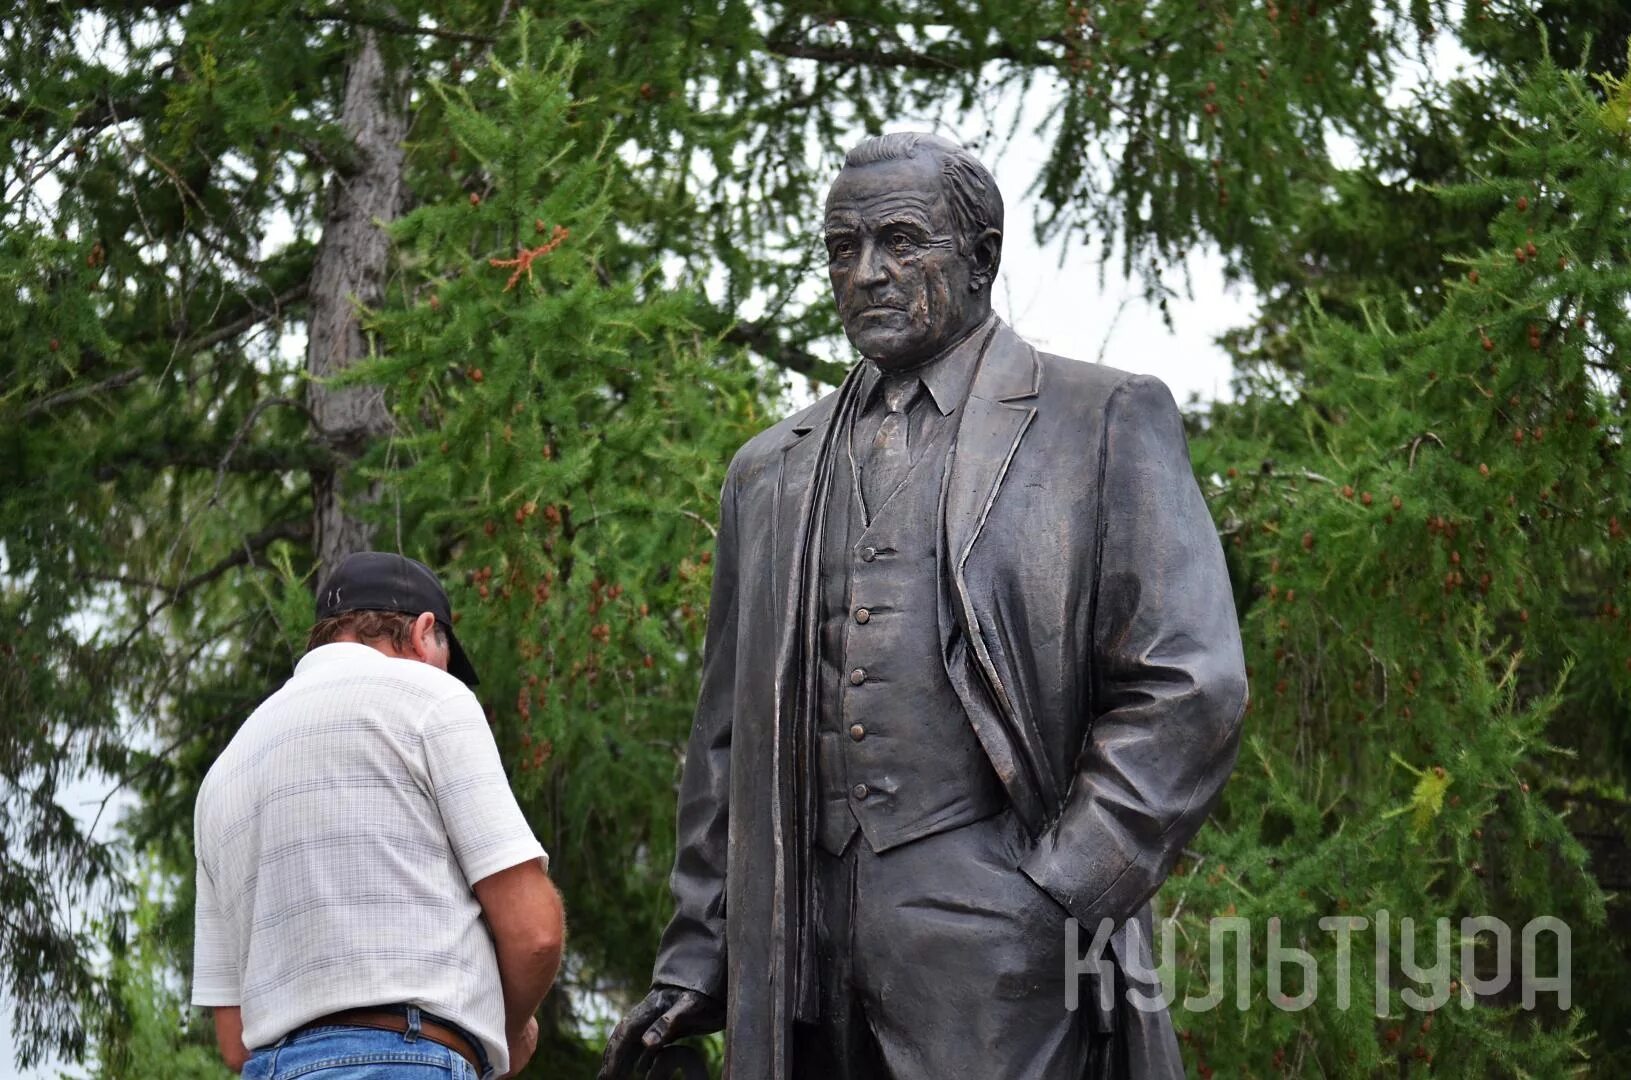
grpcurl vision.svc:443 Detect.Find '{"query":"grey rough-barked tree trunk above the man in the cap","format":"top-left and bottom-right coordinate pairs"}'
top-left (307, 29), bottom-right (408, 578)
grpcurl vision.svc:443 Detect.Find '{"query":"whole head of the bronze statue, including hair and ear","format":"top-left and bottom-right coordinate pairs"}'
top-left (825, 132), bottom-right (1003, 370)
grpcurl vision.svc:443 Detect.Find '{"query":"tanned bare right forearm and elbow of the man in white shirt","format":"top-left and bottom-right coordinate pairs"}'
top-left (475, 860), bottom-right (566, 1070)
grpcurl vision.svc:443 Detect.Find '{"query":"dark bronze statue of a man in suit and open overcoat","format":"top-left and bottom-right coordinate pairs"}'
top-left (602, 134), bottom-right (1246, 1080)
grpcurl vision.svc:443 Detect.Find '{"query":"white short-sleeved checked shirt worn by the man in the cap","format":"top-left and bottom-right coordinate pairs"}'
top-left (192, 643), bottom-right (548, 1075)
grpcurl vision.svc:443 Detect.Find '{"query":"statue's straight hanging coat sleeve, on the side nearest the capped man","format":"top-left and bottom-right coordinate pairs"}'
top-left (652, 470), bottom-right (739, 1000)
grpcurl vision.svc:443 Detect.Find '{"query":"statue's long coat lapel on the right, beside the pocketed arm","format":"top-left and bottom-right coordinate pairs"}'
top-left (939, 323), bottom-right (1059, 834)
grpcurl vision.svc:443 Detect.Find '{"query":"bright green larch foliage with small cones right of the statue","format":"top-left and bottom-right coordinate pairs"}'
top-left (1182, 53), bottom-right (1631, 1077)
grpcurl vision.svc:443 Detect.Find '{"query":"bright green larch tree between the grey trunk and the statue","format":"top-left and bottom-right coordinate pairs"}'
top-left (354, 27), bottom-right (768, 982)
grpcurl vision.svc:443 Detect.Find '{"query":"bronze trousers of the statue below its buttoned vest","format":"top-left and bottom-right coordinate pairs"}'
top-left (793, 809), bottom-right (1117, 1080)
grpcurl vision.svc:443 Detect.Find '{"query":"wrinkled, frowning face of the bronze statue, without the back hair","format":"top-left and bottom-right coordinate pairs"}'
top-left (825, 152), bottom-right (990, 370)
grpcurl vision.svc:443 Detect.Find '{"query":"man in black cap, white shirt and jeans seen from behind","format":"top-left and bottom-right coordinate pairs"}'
top-left (192, 551), bottom-right (564, 1080)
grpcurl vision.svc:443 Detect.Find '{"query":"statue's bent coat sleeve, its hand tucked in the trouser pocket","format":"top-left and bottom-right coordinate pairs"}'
top-left (1021, 375), bottom-right (1246, 925)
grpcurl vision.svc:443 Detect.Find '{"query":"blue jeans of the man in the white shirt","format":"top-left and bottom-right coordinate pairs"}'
top-left (243, 1008), bottom-right (480, 1080)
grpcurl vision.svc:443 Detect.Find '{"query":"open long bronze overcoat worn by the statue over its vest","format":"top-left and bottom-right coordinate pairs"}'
top-left (654, 323), bottom-right (1246, 1080)
